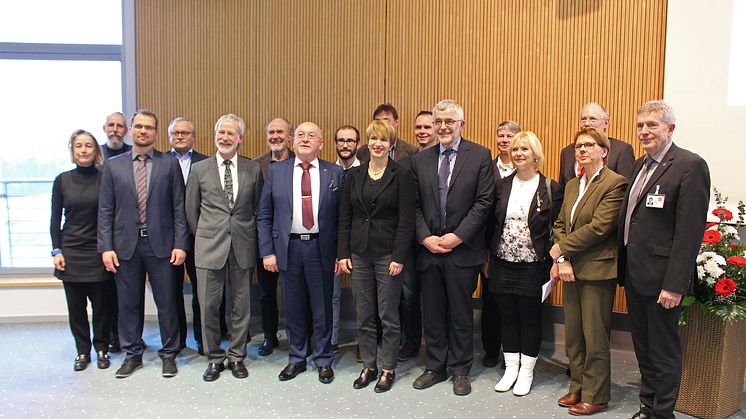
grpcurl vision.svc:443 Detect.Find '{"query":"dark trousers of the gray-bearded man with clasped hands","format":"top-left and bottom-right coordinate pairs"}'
top-left (420, 254), bottom-right (480, 375)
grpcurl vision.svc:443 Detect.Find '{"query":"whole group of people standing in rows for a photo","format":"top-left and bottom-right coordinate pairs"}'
top-left (51, 100), bottom-right (710, 418)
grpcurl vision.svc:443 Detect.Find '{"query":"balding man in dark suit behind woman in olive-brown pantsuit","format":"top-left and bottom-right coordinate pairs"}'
top-left (559, 102), bottom-right (635, 188)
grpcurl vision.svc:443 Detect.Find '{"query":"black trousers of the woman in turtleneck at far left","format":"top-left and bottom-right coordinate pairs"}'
top-left (62, 281), bottom-right (116, 354)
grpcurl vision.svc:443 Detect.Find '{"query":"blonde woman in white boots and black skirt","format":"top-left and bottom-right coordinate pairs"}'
top-left (482, 131), bottom-right (562, 396)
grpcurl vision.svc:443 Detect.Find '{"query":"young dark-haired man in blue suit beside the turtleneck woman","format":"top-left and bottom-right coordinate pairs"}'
top-left (98, 109), bottom-right (189, 378)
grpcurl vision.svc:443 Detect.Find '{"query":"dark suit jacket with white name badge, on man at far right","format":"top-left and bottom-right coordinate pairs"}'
top-left (618, 144), bottom-right (710, 296)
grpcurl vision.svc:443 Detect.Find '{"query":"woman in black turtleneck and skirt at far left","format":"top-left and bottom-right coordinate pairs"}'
top-left (49, 130), bottom-right (116, 371)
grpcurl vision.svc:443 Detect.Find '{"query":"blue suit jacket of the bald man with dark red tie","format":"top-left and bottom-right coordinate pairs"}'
top-left (257, 158), bottom-right (344, 271)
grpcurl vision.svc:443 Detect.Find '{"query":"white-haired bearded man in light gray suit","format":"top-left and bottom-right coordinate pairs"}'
top-left (186, 114), bottom-right (263, 381)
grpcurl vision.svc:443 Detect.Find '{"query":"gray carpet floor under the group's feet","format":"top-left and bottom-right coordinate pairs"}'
top-left (0, 321), bottom-right (746, 419)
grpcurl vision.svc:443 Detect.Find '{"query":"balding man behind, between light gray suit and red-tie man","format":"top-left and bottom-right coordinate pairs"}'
top-left (256, 118), bottom-right (295, 356)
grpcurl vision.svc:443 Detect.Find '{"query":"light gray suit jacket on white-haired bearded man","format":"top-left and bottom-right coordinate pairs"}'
top-left (186, 156), bottom-right (264, 270)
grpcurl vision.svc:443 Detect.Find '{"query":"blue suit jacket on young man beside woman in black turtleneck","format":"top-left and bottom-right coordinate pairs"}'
top-left (98, 150), bottom-right (189, 260)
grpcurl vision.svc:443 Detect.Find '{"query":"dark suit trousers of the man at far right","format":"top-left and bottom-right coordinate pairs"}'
top-left (624, 280), bottom-right (681, 418)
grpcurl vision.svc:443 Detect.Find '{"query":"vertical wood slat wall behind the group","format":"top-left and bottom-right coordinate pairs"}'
top-left (136, 0), bottom-right (667, 311)
